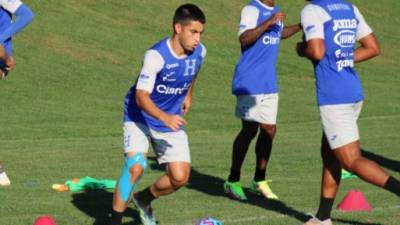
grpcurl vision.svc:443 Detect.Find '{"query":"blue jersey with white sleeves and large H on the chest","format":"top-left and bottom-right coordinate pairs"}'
top-left (124, 38), bottom-right (206, 132)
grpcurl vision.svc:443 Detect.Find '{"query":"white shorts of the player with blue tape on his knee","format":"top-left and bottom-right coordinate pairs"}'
top-left (123, 122), bottom-right (190, 164)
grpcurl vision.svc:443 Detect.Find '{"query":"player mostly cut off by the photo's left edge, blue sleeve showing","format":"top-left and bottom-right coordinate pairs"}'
top-left (0, 0), bottom-right (33, 186)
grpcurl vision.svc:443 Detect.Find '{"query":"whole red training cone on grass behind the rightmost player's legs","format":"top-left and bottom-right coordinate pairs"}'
top-left (336, 190), bottom-right (372, 212)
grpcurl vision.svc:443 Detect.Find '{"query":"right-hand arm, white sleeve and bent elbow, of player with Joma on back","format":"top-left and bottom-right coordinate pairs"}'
top-left (353, 5), bottom-right (380, 63)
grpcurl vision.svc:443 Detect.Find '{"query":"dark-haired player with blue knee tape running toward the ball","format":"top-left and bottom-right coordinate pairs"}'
top-left (111, 4), bottom-right (206, 225)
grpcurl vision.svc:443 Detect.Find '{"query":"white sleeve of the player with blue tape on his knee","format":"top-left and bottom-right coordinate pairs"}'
top-left (136, 49), bottom-right (164, 93)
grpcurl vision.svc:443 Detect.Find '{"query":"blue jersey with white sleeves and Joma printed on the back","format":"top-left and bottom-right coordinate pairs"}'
top-left (301, 0), bottom-right (372, 106)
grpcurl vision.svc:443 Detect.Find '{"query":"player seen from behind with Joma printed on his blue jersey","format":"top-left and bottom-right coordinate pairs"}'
top-left (297, 0), bottom-right (400, 225)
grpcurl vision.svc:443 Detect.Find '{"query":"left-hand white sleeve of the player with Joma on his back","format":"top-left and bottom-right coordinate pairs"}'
top-left (301, 4), bottom-right (331, 41)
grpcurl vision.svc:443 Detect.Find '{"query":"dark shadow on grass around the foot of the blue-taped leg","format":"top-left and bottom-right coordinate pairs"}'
top-left (71, 190), bottom-right (141, 225)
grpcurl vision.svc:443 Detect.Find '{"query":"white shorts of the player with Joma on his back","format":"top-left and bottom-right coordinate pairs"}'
top-left (319, 101), bottom-right (363, 149)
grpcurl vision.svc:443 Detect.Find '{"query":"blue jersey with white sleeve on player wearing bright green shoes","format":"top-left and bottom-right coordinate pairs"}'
top-left (232, 0), bottom-right (283, 95)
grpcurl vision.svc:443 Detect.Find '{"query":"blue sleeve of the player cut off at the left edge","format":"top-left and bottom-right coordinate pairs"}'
top-left (0, 4), bottom-right (34, 43)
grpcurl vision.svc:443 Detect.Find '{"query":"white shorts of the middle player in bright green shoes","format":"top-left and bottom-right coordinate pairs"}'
top-left (235, 93), bottom-right (279, 125)
